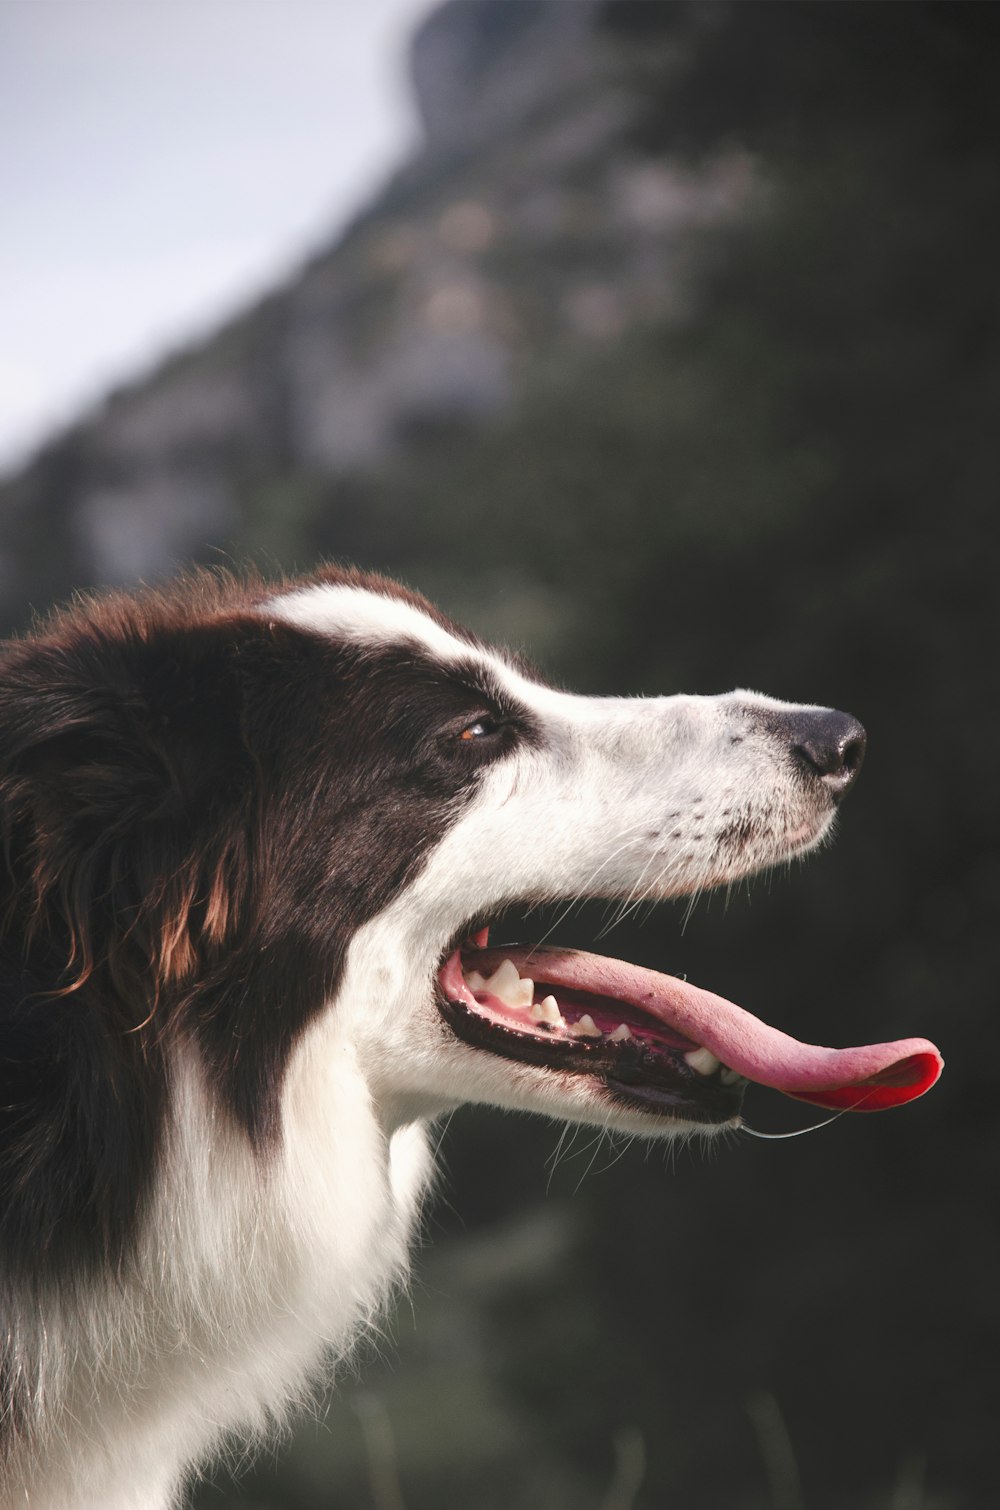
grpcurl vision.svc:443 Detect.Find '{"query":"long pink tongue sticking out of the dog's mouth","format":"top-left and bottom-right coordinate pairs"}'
top-left (462, 948), bottom-right (944, 1111)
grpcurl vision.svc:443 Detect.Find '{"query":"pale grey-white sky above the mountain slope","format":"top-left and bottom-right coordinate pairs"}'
top-left (0, 0), bottom-right (432, 470)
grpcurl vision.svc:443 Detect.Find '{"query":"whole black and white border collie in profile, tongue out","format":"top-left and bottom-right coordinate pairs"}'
top-left (0, 569), bottom-right (938, 1510)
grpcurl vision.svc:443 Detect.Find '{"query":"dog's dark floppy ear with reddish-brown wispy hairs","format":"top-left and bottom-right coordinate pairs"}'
top-left (0, 618), bottom-right (254, 1025)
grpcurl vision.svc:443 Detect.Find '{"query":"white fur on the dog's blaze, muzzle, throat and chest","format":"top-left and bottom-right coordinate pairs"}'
top-left (0, 586), bottom-right (829, 1510)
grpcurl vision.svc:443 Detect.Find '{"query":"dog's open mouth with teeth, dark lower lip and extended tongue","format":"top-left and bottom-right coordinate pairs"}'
top-left (438, 929), bottom-right (943, 1123)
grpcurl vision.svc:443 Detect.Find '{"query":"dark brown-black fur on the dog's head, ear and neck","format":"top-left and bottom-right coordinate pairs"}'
top-left (0, 570), bottom-right (533, 1285)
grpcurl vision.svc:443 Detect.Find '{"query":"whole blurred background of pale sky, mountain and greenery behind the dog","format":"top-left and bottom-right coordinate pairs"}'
top-left (0, 0), bottom-right (1000, 1510)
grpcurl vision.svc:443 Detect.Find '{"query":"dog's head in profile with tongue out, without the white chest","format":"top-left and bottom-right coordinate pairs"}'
top-left (0, 571), bottom-right (937, 1268)
